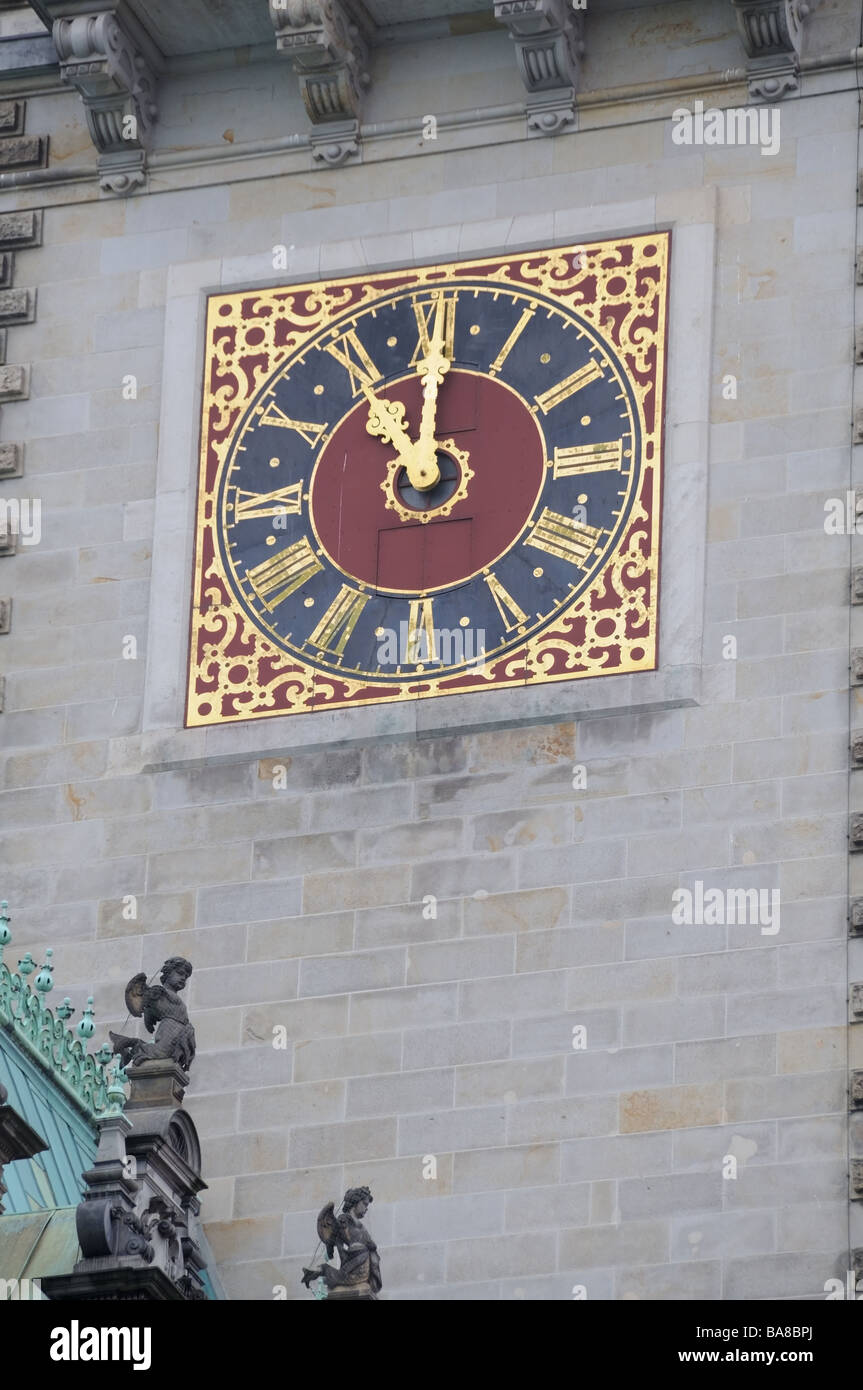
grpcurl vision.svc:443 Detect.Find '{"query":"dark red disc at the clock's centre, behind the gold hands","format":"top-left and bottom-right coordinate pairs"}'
top-left (310, 368), bottom-right (546, 594)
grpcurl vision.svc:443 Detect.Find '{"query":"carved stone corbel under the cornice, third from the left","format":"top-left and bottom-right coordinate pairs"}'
top-left (495, 0), bottom-right (584, 135)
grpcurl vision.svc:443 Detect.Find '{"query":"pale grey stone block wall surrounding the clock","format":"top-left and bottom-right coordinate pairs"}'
top-left (0, 0), bottom-right (863, 1300)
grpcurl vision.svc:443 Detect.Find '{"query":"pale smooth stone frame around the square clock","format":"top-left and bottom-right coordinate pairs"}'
top-left (143, 189), bottom-right (717, 769)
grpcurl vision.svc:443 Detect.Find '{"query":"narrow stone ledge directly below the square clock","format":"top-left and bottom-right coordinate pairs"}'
top-left (129, 666), bottom-right (700, 777)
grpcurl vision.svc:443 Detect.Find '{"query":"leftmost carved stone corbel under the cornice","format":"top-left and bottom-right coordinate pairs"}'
top-left (53, 10), bottom-right (158, 195)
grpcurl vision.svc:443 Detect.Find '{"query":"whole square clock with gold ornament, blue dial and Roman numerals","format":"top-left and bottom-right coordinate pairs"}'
top-left (188, 234), bottom-right (668, 724)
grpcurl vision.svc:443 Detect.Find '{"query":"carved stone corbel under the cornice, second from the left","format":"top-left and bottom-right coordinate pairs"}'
top-left (270, 0), bottom-right (371, 167)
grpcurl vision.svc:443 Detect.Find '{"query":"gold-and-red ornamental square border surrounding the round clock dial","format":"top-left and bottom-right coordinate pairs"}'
top-left (186, 232), bottom-right (671, 727)
